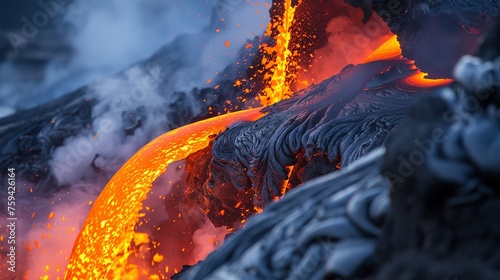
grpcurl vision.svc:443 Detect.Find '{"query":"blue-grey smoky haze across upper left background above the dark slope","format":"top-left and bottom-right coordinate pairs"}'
top-left (0, 0), bottom-right (270, 110)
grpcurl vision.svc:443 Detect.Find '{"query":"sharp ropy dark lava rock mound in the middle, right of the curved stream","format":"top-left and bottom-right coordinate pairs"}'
top-left (205, 59), bottom-right (436, 207)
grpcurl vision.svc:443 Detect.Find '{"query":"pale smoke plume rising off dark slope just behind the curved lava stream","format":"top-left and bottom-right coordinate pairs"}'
top-left (47, 1), bottom-right (268, 190)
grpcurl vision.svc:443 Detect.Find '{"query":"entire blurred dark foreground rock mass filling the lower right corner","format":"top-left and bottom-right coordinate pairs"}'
top-left (176, 19), bottom-right (500, 280)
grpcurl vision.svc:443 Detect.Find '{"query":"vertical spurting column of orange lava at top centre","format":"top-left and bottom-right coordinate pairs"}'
top-left (260, 0), bottom-right (301, 106)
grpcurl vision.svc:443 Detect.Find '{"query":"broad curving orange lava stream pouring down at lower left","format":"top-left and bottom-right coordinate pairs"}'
top-left (65, 108), bottom-right (262, 280)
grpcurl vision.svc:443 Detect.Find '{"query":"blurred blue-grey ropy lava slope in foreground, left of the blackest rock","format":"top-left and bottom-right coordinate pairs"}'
top-left (177, 149), bottom-right (388, 279)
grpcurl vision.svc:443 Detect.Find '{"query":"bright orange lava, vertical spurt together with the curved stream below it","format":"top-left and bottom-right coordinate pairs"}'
top-left (65, 0), bottom-right (300, 279)
